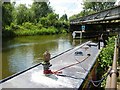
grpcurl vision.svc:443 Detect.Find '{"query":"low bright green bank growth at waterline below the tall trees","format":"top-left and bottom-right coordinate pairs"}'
top-left (2, 22), bottom-right (67, 37)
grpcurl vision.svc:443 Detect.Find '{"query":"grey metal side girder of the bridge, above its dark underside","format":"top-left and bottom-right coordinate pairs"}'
top-left (70, 6), bottom-right (120, 24)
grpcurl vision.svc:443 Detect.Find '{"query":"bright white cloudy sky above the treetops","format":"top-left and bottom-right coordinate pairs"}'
top-left (13, 0), bottom-right (120, 17)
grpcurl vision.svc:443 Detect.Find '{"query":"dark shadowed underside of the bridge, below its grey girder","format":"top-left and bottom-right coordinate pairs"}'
top-left (70, 22), bottom-right (120, 32)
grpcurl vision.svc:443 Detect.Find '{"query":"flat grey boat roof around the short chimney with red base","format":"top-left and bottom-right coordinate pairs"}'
top-left (1, 41), bottom-right (102, 88)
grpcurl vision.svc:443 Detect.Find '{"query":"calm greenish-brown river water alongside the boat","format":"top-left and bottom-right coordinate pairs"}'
top-left (0, 34), bottom-right (88, 79)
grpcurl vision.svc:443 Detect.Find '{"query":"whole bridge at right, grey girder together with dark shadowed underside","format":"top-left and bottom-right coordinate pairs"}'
top-left (70, 5), bottom-right (120, 31)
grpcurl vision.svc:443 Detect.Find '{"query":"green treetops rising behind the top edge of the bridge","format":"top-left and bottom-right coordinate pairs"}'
top-left (70, 0), bottom-right (115, 19)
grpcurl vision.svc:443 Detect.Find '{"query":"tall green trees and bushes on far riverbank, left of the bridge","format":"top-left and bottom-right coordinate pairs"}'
top-left (2, 2), bottom-right (69, 37)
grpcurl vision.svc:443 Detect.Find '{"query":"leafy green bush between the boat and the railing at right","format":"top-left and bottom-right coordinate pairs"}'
top-left (97, 36), bottom-right (115, 87)
